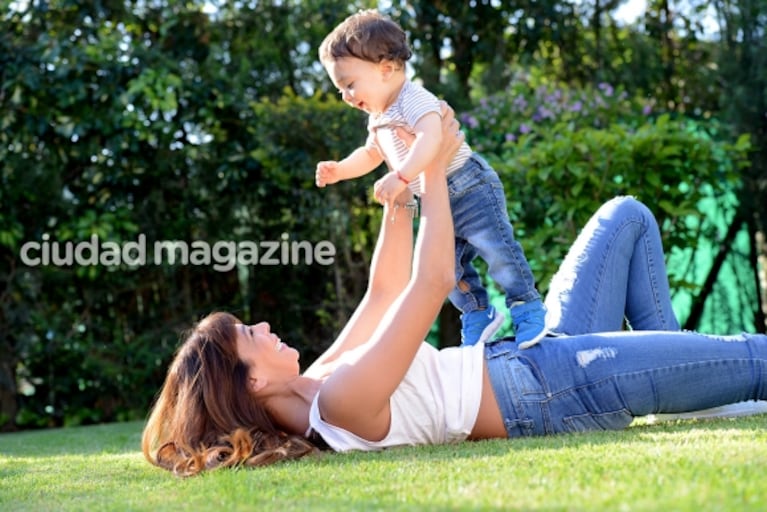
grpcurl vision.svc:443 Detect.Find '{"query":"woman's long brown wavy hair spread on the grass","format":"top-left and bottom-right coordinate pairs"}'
top-left (141, 312), bottom-right (316, 476)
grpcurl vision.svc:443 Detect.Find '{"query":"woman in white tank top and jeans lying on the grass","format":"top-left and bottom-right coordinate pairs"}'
top-left (142, 105), bottom-right (767, 475)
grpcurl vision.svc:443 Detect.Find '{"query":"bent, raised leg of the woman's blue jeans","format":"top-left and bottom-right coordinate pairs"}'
top-left (545, 196), bottom-right (679, 334)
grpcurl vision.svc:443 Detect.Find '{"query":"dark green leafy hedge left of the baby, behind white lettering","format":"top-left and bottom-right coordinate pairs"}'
top-left (0, 2), bottom-right (376, 428)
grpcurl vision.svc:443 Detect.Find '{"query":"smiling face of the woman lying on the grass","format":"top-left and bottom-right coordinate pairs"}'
top-left (235, 322), bottom-right (299, 380)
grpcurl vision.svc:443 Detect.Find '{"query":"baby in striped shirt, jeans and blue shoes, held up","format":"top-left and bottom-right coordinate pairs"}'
top-left (316, 10), bottom-right (546, 348)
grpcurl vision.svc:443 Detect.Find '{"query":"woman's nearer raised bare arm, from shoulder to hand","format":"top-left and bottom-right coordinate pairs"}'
top-left (319, 105), bottom-right (463, 440)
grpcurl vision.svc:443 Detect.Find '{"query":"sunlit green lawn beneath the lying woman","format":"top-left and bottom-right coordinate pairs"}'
top-left (0, 415), bottom-right (767, 512)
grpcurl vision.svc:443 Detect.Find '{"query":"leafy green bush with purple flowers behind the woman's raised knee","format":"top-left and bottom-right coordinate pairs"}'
top-left (462, 82), bottom-right (749, 292)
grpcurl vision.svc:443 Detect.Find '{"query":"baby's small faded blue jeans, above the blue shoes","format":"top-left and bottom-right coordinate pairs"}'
top-left (447, 154), bottom-right (540, 313)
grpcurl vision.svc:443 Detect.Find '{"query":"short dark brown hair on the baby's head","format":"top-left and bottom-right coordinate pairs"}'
top-left (319, 9), bottom-right (413, 66)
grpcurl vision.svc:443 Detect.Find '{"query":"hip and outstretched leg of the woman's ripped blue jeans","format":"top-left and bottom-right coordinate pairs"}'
top-left (485, 331), bottom-right (767, 437)
